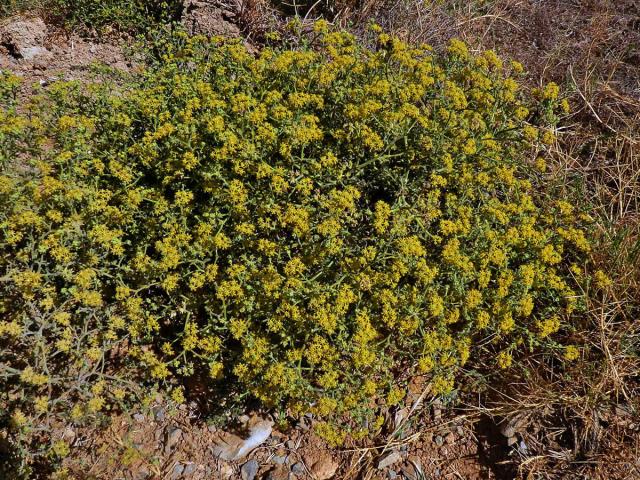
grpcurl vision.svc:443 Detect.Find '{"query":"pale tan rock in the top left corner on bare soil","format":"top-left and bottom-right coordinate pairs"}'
top-left (0, 17), bottom-right (49, 60)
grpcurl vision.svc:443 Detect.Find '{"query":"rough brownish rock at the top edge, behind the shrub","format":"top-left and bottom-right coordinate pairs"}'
top-left (182, 0), bottom-right (240, 37)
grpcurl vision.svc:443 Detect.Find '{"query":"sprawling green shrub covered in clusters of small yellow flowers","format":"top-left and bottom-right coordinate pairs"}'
top-left (0, 23), bottom-right (590, 468)
